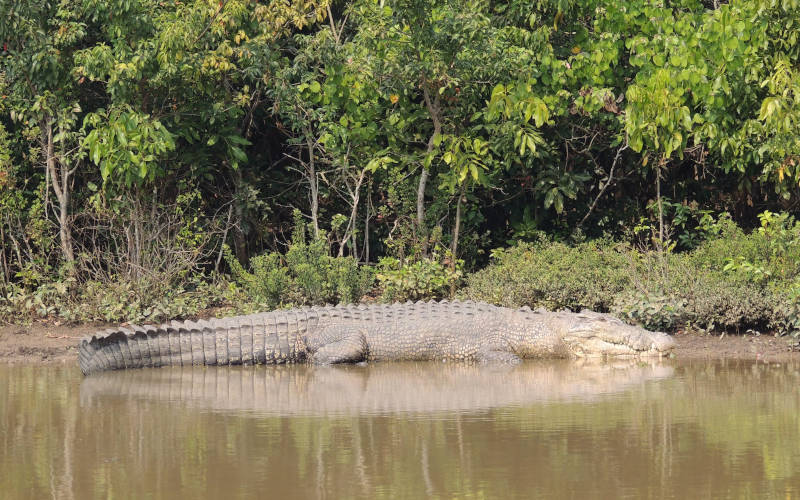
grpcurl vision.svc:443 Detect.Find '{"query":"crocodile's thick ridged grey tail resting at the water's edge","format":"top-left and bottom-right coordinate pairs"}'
top-left (78, 313), bottom-right (306, 375)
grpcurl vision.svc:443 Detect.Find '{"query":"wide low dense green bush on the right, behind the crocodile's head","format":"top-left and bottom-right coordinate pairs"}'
top-left (461, 212), bottom-right (800, 335)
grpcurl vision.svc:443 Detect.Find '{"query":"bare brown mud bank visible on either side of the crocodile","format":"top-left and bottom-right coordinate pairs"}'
top-left (0, 322), bottom-right (800, 363)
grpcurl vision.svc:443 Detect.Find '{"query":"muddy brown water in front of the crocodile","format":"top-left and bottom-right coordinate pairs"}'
top-left (0, 362), bottom-right (800, 499)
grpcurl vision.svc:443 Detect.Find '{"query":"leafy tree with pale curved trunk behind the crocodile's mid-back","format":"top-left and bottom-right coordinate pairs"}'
top-left (357, 0), bottom-right (502, 254)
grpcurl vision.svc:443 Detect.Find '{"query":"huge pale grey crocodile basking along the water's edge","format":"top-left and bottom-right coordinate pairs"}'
top-left (78, 301), bottom-right (674, 375)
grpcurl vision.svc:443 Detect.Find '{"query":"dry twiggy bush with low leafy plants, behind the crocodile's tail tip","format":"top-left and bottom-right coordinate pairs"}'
top-left (0, 191), bottom-right (231, 322)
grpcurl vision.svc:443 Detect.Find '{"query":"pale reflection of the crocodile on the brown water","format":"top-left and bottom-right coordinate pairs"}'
top-left (80, 361), bottom-right (673, 415)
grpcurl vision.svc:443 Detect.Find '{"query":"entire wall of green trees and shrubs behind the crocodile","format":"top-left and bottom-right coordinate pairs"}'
top-left (0, 0), bottom-right (800, 340)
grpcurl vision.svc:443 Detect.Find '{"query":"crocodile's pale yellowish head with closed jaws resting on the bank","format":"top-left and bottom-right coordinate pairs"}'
top-left (556, 310), bottom-right (675, 358)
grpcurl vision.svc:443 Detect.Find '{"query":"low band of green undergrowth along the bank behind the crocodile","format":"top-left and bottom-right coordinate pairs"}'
top-left (0, 212), bottom-right (800, 337)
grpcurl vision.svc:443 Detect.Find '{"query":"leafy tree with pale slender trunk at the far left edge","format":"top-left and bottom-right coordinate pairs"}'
top-left (0, 1), bottom-right (86, 265)
